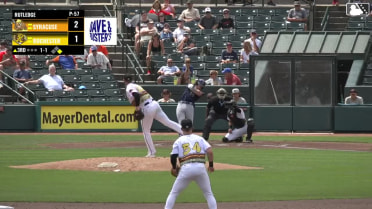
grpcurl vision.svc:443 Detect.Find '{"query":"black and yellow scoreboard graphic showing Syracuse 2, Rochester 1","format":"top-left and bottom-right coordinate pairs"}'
top-left (12, 10), bottom-right (84, 55)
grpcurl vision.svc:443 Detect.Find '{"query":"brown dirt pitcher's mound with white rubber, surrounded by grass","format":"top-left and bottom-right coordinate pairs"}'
top-left (11, 157), bottom-right (262, 172)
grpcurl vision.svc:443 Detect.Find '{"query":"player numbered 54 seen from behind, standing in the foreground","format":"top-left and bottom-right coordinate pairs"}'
top-left (164, 119), bottom-right (217, 209)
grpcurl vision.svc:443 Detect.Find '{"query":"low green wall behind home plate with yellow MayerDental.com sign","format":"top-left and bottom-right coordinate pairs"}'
top-left (0, 102), bottom-right (372, 132)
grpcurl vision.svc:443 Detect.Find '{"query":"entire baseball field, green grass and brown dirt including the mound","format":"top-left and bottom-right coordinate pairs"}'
top-left (0, 133), bottom-right (372, 209)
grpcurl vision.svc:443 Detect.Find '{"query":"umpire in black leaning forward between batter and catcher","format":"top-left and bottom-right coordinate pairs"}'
top-left (203, 88), bottom-right (232, 141)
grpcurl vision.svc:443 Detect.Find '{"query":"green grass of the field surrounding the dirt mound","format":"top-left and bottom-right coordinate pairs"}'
top-left (0, 134), bottom-right (372, 203)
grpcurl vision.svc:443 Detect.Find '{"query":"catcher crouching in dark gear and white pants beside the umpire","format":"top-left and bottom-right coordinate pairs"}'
top-left (222, 100), bottom-right (254, 143)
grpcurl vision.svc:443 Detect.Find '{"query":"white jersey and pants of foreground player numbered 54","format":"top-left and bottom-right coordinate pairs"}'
top-left (164, 134), bottom-right (217, 209)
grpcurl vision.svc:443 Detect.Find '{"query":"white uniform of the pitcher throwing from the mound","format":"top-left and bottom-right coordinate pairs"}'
top-left (126, 83), bottom-right (182, 157)
